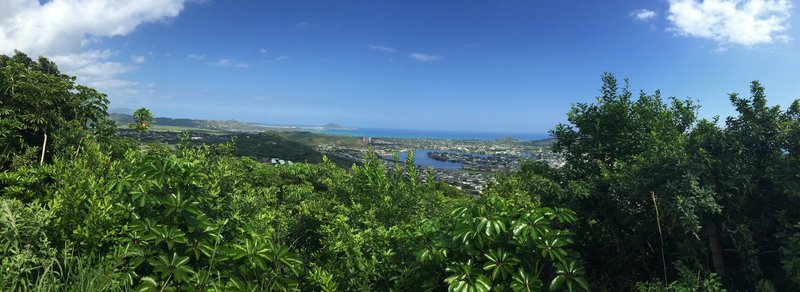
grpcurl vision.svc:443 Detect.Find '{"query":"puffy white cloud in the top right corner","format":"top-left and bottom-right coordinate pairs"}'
top-left (667, 0), bottom-right (792, 46)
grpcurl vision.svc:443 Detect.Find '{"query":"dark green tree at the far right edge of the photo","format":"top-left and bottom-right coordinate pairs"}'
top-left (693, 81), bottom-right (800, 290)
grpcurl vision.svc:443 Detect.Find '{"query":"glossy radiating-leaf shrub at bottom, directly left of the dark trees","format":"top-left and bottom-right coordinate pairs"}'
top-left (417, 196), bottom-right (588, 291)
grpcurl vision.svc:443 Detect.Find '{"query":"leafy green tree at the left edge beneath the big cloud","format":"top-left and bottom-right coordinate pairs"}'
top-left (0, 52), bottom-right (108, 169)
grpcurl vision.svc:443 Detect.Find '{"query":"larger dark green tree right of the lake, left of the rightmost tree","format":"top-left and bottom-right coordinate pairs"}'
top-left (544, 74), bottom-right (719, 289)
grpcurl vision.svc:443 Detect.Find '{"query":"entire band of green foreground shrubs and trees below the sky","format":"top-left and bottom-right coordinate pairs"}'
top-left (0, 53), bottom-right (800, 291)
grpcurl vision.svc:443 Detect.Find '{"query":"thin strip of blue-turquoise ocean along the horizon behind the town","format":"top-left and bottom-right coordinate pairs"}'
top-left (315, 128), bottom-right (550, 141)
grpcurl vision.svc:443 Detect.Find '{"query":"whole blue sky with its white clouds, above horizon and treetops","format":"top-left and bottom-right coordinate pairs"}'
top-left (0, 0), bottom-right (800, 133)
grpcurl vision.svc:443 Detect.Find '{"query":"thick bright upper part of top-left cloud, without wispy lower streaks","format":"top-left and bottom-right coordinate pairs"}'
top-left (0, 0), bottom-right (186, 55)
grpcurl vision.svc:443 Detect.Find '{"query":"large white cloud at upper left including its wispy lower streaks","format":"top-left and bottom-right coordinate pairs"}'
top-left (0, 0), bottom-right (192, 104)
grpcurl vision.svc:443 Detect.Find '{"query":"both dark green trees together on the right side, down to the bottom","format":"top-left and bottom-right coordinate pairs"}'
top-left (514, 74), bottom-right (800, 290)
